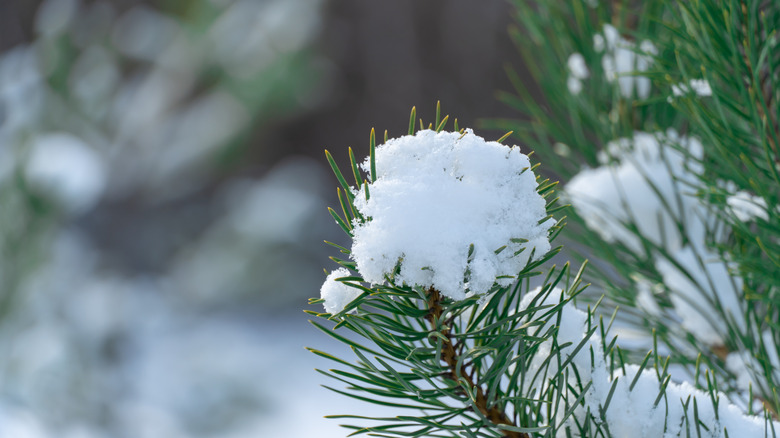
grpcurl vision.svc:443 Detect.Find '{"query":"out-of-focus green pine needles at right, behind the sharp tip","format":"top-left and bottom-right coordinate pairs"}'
top-left (486, 0), bottom-right (780, 422)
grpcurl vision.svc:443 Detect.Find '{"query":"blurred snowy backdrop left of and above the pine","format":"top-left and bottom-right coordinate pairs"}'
top-left (0, 0), bottom-right (520, 438)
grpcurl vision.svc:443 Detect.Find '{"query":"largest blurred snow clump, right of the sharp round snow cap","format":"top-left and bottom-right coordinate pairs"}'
top-left (566, 130), bottom-right (704, 254)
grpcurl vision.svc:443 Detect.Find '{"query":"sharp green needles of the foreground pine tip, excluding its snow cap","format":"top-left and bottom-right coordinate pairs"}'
top-left (308, 106), bottom-right (596, 436)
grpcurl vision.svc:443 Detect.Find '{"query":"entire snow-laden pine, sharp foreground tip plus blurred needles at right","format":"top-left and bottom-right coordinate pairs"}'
top-left (308, 0), bottom-right (780, 438)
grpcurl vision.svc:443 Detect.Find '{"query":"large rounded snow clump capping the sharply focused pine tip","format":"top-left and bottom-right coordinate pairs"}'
top-left (352, 130), bottom-right (555, 300)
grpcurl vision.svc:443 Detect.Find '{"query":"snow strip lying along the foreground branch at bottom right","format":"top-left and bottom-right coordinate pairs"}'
top-left (521, 288), bottom-right (780, 438)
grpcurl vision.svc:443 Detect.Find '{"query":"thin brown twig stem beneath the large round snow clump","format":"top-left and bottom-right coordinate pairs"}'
top-left (426, 288), bottom-right (530, 438)
